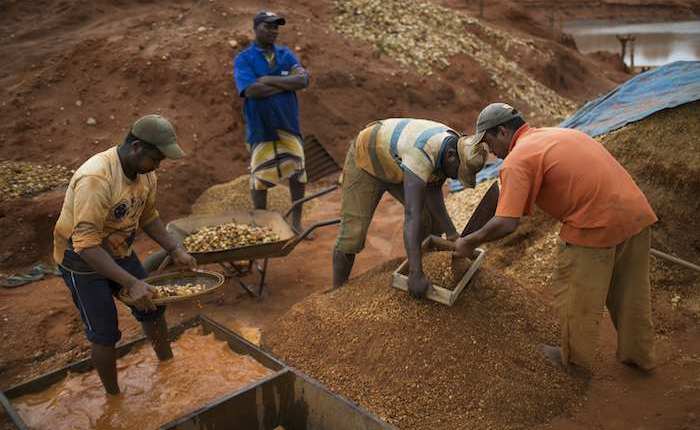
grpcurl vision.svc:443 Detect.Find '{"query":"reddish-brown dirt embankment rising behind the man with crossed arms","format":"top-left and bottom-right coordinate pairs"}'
top-left (0, 0), bottom-right (624, 268)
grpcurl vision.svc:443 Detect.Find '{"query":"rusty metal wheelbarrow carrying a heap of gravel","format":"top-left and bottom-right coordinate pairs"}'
top-left (144, 185), bottom-right (340, 298)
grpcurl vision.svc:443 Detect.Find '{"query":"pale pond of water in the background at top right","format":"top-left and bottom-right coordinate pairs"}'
top-left (563, 21), bottom-right (700, 66)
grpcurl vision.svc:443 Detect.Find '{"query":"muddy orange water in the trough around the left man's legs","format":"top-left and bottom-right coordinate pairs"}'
top-left (13, 328), bottom-right (272, 430)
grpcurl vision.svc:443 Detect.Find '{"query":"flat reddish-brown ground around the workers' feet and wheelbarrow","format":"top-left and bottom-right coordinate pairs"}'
top-left (0, 193), bottom-right (700, 430)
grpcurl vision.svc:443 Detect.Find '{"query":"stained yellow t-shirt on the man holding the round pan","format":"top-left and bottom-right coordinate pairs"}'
top-left (53, 146), bottom-right (159, 269)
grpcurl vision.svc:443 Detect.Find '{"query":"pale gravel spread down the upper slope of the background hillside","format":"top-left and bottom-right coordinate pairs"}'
top-left (334, 0), bottom-right (575, 118)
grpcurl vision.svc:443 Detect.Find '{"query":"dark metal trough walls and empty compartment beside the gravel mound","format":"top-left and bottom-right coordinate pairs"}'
top-left (0, 315), bottom-right (394, 430)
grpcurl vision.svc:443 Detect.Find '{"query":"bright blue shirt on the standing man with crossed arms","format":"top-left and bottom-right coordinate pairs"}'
top-left (233, 43), bottom-right (301, 145)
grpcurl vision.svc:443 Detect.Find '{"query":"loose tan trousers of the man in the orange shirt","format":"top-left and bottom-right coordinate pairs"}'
top-left (555, 227), bottom-right (655, 370)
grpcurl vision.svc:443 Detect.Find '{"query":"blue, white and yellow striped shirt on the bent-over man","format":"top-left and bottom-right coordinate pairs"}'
top-left (355, 118), bottom-right (459, 184)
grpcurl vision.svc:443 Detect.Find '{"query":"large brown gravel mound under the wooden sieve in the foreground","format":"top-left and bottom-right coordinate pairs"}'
top-left (263, 261), bottom-right (585, 430)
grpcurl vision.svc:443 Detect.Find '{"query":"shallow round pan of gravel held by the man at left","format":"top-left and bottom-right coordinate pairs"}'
top-left (119, 270), bottom-right (224, 305)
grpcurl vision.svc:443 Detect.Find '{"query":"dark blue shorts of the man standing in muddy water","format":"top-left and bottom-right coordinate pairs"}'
top-left (59, 254), bottom-right (165, 346)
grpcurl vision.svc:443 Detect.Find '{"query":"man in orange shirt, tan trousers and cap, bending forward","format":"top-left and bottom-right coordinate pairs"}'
top-left (456, 103), bottom-right (657, 370)
